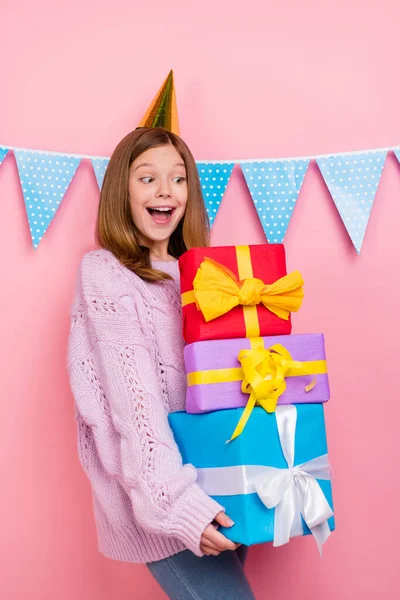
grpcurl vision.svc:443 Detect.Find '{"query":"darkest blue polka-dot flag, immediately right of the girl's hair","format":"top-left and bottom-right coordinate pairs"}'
top-left (196, 162), bottom-right (235, 226)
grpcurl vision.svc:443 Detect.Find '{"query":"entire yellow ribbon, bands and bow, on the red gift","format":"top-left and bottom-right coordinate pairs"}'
top-left (182, 246), bottom-right (304, 337)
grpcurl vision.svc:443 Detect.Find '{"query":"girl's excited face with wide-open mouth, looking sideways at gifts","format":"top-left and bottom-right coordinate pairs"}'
top-left (129, 144), bottom-right (188, 249)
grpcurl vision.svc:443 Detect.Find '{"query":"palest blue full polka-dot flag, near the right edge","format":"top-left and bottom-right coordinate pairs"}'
top-left (317, 150), bottom-right (387, 254)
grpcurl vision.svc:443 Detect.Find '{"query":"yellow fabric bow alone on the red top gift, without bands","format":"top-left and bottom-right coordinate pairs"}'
top-left (193, 258), bottom-right (304, 322)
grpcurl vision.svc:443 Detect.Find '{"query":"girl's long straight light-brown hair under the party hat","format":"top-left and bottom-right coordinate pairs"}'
top-left (96, 127), bottom-right (210, 282)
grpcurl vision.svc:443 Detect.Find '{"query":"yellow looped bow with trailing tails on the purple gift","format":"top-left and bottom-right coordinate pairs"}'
top-left (228, 344), bottom-right (326, 442)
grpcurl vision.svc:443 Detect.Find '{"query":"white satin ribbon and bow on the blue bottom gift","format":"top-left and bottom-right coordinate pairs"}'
top-left (197, 405), bottom-right (333, 554)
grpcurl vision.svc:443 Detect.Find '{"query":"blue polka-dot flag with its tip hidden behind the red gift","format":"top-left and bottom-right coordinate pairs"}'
top-left (240, 159), bottom-right (310, 244)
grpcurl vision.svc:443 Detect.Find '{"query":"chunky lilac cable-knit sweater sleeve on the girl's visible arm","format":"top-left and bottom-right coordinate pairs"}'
top-left (71, 252), bottom-right (224, 556)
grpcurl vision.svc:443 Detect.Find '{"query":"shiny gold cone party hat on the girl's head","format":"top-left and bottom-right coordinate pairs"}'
top-left (138, 69), bottom-right (179, 135)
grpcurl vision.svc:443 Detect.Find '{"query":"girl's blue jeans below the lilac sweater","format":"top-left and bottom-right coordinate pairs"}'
top-left (147, 546), bottom-right (256, 600)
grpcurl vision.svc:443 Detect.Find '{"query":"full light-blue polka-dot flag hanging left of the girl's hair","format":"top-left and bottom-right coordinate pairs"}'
top-left (15, 150), bottom-right (81, 249)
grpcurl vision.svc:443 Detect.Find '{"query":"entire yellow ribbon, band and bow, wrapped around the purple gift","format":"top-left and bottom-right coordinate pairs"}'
top-left (187, 338), bottom-right (327, 441)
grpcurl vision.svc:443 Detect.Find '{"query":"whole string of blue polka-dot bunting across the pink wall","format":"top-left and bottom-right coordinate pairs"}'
top-left (0, 145), bottom-right (400, 254)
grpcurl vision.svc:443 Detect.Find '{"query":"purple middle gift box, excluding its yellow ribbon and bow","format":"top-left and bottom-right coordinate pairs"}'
top-left (185, 333), bottom-right (330, 413)
